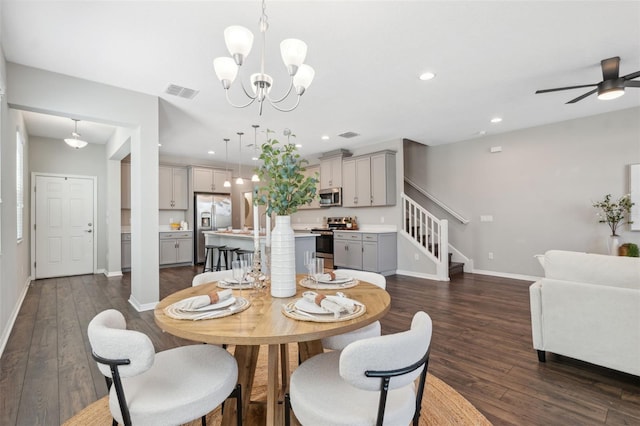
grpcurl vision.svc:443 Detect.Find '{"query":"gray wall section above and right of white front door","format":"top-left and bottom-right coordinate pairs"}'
top-left (29, 136), bottom-right (107, 271)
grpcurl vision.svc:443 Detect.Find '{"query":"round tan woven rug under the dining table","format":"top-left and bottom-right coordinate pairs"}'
top-left (63, 345), bottom-right (491, 426)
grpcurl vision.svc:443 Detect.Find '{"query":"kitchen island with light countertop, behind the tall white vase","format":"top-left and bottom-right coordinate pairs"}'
top-left (203, 230), bottom-right (317, 274)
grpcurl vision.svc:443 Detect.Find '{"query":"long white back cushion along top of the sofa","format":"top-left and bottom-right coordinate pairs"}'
top-left (543, 250), bottom-right (640, 289)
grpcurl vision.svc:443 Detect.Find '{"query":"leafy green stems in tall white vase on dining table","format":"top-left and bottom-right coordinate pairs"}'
top-left (254, 130), bottom-right (318, 297)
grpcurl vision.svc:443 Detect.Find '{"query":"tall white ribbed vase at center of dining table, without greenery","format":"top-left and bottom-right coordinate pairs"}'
top-left (271, 216), bottom-right (296, 297)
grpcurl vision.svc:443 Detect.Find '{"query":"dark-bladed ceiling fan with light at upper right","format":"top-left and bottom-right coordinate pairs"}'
top-left (536, 56), bottom-right (640, 104)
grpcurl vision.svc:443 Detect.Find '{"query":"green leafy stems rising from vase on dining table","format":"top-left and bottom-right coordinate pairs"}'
top-left (253, 130), bottom-right (318, 216)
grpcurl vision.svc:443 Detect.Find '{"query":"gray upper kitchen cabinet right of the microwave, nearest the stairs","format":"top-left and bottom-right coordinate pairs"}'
top-left (342, 151), bottom-right (396, 207)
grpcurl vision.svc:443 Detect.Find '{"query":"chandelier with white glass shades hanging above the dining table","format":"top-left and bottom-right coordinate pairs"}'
top-left (213, 0), bottom-right (315, 115)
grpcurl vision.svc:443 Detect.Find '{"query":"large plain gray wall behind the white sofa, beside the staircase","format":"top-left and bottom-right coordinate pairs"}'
top-left (404, 108), bottom-right (640, 276)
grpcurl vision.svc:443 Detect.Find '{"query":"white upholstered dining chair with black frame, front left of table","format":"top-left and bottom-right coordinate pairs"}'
top-left (87, 309), bottom-right (242, 426)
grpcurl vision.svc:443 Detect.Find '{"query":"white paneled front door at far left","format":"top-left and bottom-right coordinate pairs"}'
top-left (34, 176), bottom-right (95, 278)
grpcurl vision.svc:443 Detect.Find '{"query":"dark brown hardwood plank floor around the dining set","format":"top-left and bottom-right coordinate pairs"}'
top-left (0, 267), bottom-right (640, 426)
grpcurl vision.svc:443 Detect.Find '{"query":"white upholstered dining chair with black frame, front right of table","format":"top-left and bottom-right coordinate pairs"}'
top-left (285, 312), bottom-right (432, 426)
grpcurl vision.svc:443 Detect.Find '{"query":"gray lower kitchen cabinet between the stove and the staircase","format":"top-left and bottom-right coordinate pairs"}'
top-left (333, 231), bottom-right (398, 274)
